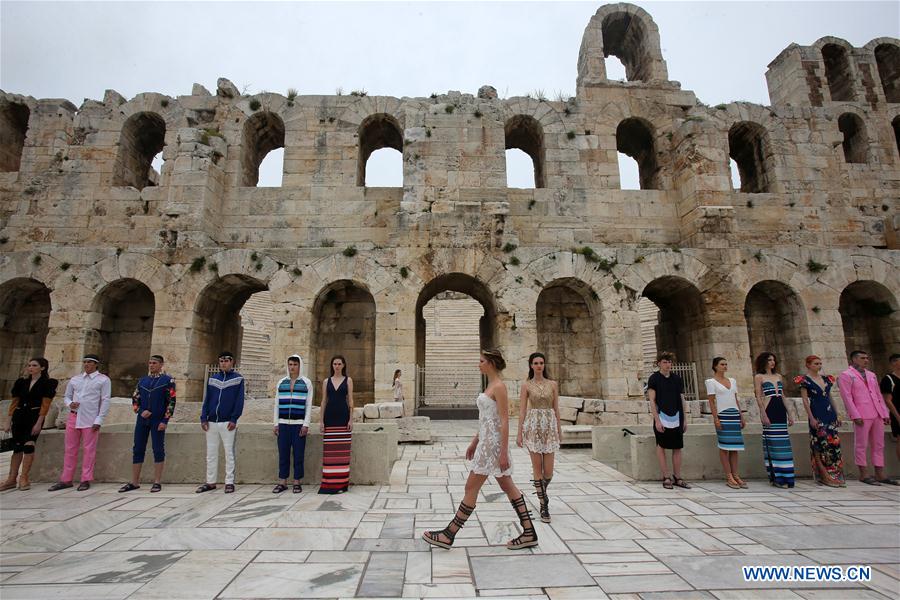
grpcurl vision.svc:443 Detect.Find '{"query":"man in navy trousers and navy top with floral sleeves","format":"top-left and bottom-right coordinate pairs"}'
top-left (119, 354), bottom-right (175, 492)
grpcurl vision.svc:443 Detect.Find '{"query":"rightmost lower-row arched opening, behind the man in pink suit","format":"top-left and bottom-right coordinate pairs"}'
top-left (839, 281), bottom-right (900, 374)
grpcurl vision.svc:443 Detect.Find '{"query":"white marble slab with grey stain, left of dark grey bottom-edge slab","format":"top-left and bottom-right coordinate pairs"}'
top-left (219, 563), bottom-right (363, 598)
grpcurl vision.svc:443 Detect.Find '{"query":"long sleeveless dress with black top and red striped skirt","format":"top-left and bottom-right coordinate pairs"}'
top-left (319, 377), bottom-right (352, 494)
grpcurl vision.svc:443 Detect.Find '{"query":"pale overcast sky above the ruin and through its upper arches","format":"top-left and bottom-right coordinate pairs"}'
top-left (0, 0), bottom-right (900, 187)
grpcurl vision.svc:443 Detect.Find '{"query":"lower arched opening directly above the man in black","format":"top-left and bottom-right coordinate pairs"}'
top-left (639, 275), bottom-right (712, 373)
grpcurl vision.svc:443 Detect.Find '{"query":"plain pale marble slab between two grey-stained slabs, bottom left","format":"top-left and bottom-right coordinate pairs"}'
top-left (131, 550), bottom-right (256, 600)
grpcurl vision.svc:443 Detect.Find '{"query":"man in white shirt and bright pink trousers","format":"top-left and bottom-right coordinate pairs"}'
top-left (49, 354), bottom-right (112, 492)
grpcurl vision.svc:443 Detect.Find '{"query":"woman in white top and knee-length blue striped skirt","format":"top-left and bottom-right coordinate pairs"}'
top-left (706, 356), bottom-right (747, 489)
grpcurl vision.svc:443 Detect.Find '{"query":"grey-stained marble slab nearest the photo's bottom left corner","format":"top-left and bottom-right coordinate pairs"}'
top-left (10, 552), bottom-right (185, 584)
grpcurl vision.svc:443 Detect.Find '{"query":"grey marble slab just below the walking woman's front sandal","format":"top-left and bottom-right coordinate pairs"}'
top-left (472, 554), bottom-right (592, 589)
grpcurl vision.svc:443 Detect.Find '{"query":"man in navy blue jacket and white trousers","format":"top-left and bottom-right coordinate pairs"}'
top-left (197, 352), bottom-right (244, 494)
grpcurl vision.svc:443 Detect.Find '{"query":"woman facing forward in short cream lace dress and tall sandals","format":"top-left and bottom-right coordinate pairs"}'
top-left (516, 352), bottom-right (562, 523)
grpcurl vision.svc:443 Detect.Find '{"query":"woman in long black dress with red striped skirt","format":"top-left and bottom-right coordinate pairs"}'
top-left (319, 355), bottom-right (353, 494)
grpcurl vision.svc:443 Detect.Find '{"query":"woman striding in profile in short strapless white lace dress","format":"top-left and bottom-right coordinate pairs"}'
top-left (422, 350), bottom-right (538, 550)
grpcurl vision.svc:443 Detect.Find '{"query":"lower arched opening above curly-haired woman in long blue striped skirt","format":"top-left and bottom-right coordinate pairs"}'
top-left (744, 280), bottom-right (811, 395)
